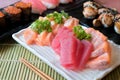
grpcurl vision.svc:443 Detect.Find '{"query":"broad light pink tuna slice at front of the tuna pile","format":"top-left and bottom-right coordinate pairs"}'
top-left (60, 36), bottom-right (77, 69)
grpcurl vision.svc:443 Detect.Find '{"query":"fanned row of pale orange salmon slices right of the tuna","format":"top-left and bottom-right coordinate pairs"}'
top-left (85, 28), bottom-right (111, 69)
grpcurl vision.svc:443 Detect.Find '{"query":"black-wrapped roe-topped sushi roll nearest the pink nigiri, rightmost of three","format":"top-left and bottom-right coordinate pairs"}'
top-left (14, 1), bottom-right (31, 21)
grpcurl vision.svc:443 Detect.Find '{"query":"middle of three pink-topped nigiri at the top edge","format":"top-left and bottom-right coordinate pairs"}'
top-left (41, 0), bottom-right (59, 9)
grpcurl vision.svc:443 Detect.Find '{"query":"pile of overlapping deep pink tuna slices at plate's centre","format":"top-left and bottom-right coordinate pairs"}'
top-left (52, 27), bottom-right (93, 70)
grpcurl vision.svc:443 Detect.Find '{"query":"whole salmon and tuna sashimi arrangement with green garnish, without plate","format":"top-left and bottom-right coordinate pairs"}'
top-left (23, 12), bottom-right (111, 70)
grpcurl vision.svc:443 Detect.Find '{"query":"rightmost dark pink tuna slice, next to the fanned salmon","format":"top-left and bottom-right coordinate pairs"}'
top-left (79, 40), bottom-right (93, 70)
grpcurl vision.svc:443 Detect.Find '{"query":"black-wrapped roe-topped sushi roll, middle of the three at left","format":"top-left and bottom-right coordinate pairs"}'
top-left (3, 6), bottom-right (22, 25)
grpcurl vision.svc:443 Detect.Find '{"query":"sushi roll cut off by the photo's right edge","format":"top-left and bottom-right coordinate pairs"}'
top-left (114, 14), bottom-right (120, 34)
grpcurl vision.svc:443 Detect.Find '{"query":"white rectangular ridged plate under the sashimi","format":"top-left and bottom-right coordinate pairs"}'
top-left (12, 29), bottom-right (120, 80)
